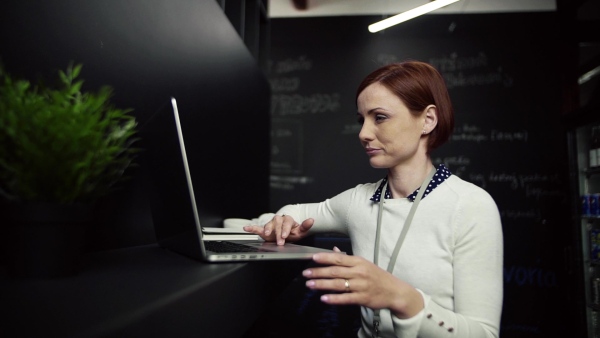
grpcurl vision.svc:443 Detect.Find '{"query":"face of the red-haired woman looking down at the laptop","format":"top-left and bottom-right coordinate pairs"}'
top-left (357, 83), bottom-right (426, 168)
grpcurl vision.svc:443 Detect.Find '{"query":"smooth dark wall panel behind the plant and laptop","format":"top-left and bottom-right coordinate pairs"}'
top-left (0, 0), bottom-right (270, 250)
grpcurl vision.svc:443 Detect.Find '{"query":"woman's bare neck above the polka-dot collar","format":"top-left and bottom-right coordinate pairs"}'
top-left (388, 157), bottom-right (434, 198)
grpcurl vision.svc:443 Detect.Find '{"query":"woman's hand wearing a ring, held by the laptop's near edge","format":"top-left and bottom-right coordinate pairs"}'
top-left (302, 248), bottom-right (424, 318)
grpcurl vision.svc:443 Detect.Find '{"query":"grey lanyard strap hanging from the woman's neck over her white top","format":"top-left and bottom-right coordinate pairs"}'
top-left (373, 168), bottom-right (436, 337)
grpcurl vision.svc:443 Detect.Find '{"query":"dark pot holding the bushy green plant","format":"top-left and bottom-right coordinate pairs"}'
top-left (5, 203), bottom-right (92, 278)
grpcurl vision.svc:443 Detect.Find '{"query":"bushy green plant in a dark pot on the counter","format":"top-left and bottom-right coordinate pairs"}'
top-left (0, 64), bottom-right (137, 277)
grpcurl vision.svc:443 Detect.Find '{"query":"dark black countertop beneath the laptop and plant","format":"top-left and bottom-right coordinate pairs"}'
top-left (0, 245), bottom-right (307, 338)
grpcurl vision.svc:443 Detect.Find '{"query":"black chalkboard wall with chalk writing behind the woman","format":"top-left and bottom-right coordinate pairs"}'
top-left (268, 13), bottom-right (579, 337)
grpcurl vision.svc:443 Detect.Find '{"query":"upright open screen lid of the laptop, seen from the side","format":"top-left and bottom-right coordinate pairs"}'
top-left (140, 98), bottom-right (202, 259)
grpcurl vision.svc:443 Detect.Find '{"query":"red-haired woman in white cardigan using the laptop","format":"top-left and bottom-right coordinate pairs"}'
top-left (245, 61), bottom-right (503, 338)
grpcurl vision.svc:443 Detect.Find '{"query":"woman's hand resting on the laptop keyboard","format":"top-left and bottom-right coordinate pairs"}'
top-left (244, 215), bottom-right (315, 245)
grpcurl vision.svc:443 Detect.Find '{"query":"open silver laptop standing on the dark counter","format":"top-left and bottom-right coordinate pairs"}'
top-left (140, 98), bottom-right (332, 262)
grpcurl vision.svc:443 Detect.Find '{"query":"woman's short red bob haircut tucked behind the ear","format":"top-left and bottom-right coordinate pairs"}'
top-left (356, 60), bottom-right (454, 152)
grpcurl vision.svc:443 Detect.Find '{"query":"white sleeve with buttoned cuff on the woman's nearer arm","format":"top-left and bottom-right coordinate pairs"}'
top-left (392, 189), bottom-right (503, 338)
